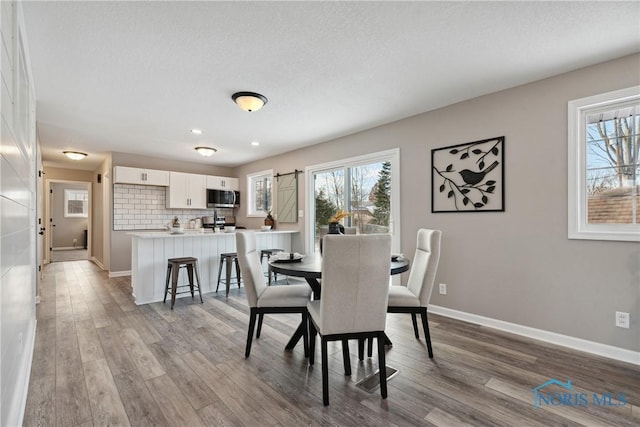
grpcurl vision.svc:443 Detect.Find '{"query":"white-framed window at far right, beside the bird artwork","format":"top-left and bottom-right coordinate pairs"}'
top-left (568, 86), bottom-right (640, 241)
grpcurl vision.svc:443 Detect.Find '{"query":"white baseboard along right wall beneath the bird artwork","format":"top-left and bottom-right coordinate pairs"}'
top-left (429, 305), bottom-right (640, 365)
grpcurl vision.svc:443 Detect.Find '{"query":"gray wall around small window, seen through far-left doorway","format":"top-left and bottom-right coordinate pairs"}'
top-left (51, 182), bottom-right (90, 249)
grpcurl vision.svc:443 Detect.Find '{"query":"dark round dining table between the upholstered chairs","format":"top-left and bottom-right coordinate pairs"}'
top-left (269, 253), bottom-right (410, 350)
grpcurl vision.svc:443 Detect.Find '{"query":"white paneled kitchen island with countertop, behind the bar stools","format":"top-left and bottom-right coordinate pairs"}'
top-left (127, 230), bottom-right (298, 305)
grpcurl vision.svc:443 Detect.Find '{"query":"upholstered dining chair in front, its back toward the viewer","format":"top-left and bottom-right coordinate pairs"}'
top-left (307, 234), bottom-right (391, 405)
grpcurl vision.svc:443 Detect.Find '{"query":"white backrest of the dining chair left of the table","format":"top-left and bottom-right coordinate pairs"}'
top-left (236, 231), bottom-right (267, 307)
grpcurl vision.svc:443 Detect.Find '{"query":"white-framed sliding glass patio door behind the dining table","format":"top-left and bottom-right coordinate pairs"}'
top-left (306, 149), bottom-right (400, 252)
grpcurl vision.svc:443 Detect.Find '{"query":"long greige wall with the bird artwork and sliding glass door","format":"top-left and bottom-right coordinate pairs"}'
top-left (235, 55), bottom-right (640, 351)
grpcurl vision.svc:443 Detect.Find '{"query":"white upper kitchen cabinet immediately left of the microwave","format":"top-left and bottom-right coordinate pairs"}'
top-left (166, 172), bottom-right (207, 209)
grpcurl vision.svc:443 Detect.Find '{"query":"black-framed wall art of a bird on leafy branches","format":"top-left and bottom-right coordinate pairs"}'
top-left (431, 136), bottom-right (505, 213)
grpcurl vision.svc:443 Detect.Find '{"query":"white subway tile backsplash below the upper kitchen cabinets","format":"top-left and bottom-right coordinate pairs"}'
top-left (113, 184), bottom-right (228, 230)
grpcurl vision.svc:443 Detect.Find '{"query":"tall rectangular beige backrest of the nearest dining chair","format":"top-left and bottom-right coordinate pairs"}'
top-left (318, 234), bottom-right (391, 335)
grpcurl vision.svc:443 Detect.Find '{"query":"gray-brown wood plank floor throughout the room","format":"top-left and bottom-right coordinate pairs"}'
top-left (24, 261), bottom-right (640, 427)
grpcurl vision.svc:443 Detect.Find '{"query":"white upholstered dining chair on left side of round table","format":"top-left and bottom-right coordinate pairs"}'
top-left (236, 231), bottom-right (311, 357)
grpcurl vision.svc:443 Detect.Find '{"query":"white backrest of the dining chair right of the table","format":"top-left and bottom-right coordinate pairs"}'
top-left (407, 228), bottom-right (442, 307)
